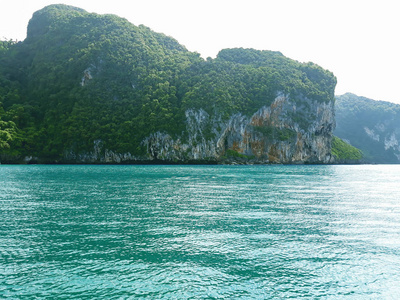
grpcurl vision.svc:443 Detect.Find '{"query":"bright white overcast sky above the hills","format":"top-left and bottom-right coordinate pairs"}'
top-left (0, 0), bottom-right (400, 104)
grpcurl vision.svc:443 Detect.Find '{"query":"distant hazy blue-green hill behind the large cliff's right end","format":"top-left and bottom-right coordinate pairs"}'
top-left (335, 93), bottom-right (400, 163)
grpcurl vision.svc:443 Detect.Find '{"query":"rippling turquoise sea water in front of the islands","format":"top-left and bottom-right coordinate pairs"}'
top-left (0, 165), bottom-right (400, 299)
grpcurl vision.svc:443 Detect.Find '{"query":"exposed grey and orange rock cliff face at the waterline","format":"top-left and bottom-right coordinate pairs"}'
top-left (65, 94), bottom-right (335, 163)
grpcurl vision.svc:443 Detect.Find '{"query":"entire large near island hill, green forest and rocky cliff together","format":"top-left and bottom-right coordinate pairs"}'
top-left (0, 5), bottom-right (346, 163)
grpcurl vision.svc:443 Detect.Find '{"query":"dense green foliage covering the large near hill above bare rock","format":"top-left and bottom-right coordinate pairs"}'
top-left (0, 5), bottom-right (336, 161)
